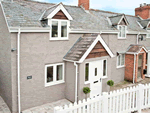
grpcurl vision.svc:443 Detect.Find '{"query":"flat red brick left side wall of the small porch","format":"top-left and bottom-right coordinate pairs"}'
top-left (125, 54), bottom-right (134, 82)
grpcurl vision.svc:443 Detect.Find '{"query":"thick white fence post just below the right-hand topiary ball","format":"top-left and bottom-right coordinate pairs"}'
top-left (102, 92), bottom-right (108, 113)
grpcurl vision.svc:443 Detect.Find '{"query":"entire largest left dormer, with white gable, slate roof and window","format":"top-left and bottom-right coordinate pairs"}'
top-left (41, 3), bottom-right (73, 40)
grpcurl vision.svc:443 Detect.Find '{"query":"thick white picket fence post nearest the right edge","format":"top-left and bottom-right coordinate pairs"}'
top-left (137, 84), bottom-right (144, 113)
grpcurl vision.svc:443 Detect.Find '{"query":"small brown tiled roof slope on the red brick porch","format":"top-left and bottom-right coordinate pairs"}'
top-left (127, 44), bottom-right (145, 53)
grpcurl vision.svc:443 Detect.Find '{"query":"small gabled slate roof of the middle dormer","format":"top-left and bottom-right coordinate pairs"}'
top-left (109, 14), bottom-right (129, 26)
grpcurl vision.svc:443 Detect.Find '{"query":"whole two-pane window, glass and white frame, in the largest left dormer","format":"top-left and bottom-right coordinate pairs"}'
top-left (50, 19), bottom-right (69, 40)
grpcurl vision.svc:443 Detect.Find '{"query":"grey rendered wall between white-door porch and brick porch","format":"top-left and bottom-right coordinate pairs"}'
top-left (102, 34), bottom-right (137, 83)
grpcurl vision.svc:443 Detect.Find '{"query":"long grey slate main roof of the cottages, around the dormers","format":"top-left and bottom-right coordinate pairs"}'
top-left (2, 0), bottom-right (146, 32)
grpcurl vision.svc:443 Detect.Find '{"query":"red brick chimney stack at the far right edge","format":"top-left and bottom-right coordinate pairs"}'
top-left (135, 3), bottom-right (150, 19)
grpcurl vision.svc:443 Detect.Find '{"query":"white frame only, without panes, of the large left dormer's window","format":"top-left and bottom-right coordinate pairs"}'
top-left (48, 19), bottom-right (70, 40)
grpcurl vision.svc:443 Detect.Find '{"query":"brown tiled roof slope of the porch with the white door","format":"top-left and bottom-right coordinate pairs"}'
top-left (64, 35), bottom-right (97, 61)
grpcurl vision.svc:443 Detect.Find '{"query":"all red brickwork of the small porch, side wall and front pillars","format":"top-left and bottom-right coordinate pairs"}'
top-left (125, 49), bottom-right (146, 82)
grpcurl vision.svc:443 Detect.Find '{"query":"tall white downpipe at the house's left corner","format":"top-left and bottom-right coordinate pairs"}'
top-left (17, 28), bottom-right (21, 113)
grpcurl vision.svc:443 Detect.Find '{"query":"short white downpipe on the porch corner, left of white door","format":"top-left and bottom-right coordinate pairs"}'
top-left (74, 62), bottom-right (78, 102)
